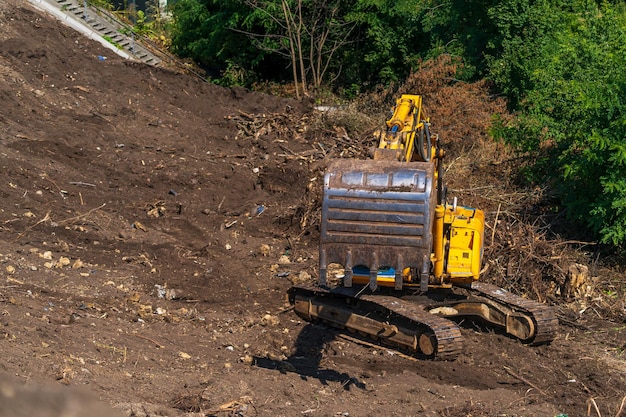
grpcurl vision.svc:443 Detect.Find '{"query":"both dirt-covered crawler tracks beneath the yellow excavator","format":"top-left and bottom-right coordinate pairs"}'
top-left (289, 283), bottom-right (558, 360)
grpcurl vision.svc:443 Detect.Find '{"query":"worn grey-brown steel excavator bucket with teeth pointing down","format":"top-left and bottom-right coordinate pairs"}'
top-left (320, 159), bottom-right (436, 291)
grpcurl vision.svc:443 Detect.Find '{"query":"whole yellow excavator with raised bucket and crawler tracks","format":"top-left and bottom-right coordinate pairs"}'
top-left (289, 94), bottom-right (558, 359)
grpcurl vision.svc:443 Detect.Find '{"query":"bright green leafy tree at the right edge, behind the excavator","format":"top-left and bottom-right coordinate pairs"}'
top-left (490, 0), bottom-right (626, 246)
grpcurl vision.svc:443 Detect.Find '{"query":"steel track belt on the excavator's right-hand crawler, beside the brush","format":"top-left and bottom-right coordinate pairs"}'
top-left (471, 282), bottom-right (559, 345)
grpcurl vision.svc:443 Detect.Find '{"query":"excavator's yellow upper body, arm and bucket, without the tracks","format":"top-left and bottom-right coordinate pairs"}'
top-left (320, 94), bottom-right (485, 291)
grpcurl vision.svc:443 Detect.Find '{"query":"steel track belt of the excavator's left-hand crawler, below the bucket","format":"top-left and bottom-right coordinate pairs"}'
top-left (290, 286), bottom-right (463, 360)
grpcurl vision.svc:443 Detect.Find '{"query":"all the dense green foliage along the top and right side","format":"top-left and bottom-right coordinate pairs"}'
top-left (165, 0), bottom-right (626, 247)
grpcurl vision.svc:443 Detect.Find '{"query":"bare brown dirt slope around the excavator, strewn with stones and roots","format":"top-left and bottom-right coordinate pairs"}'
top-left (0, 0), bottom-right (626, 417)
